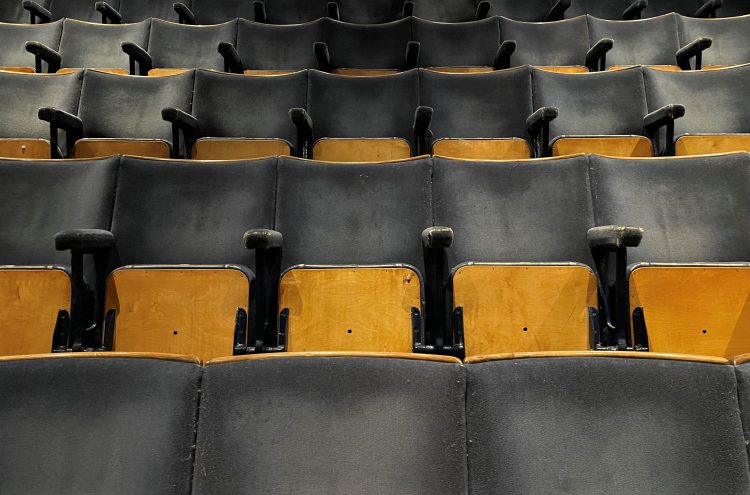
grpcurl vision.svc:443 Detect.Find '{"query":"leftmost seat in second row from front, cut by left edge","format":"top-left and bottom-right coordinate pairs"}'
top-left (0, 159), bottom-right (119, 356)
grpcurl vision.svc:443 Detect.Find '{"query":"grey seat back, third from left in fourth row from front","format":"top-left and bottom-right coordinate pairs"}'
top-left (148, 19), bottom-right (236, 70)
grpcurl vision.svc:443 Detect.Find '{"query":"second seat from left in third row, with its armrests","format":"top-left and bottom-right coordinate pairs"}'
top-left (38, 70), bottom-right (194, 158)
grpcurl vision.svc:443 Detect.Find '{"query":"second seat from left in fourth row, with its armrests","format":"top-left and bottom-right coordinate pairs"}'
top-left (26, 19), bottom-right (149, 74)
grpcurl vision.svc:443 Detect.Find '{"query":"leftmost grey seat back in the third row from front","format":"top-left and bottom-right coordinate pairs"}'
top-left (0, 71), bottom-right (83, 143)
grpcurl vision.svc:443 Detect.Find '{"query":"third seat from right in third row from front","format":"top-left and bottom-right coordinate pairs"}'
top-left (419, 67), bottom-right (532, 160)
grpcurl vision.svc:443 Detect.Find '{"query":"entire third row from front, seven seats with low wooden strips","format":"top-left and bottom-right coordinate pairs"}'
top-left (5, 65), bottom-right (750, 162)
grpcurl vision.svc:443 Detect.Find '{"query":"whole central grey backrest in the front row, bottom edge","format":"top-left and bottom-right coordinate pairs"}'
top-left (193, 357), bottom-right (467, 495)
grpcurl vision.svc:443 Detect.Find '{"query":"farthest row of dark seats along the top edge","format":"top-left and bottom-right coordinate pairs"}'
top-left (8, 0), bottom-right (750, 24)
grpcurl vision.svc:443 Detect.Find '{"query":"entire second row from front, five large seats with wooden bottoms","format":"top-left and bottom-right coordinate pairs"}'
top-left (0, 154), bottom-right (750, 359)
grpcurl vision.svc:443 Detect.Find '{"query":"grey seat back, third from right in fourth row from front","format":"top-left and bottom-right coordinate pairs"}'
top-left (500, 17), bottom-right (589, 66)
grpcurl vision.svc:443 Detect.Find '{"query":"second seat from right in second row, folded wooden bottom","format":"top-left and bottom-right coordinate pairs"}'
top-left (433, 156), bottom-right (600, 357)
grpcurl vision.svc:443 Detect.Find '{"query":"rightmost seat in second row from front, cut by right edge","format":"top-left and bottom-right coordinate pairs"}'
top-left (591, 154), bottom-right (750, 357)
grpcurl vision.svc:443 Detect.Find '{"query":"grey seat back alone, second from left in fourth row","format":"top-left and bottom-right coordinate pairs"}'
top-left (60, 19), bottom-right (151, 70)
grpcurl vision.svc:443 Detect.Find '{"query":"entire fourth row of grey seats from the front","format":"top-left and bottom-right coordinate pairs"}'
top-left (5, 14), bottom-right (750, 75)
